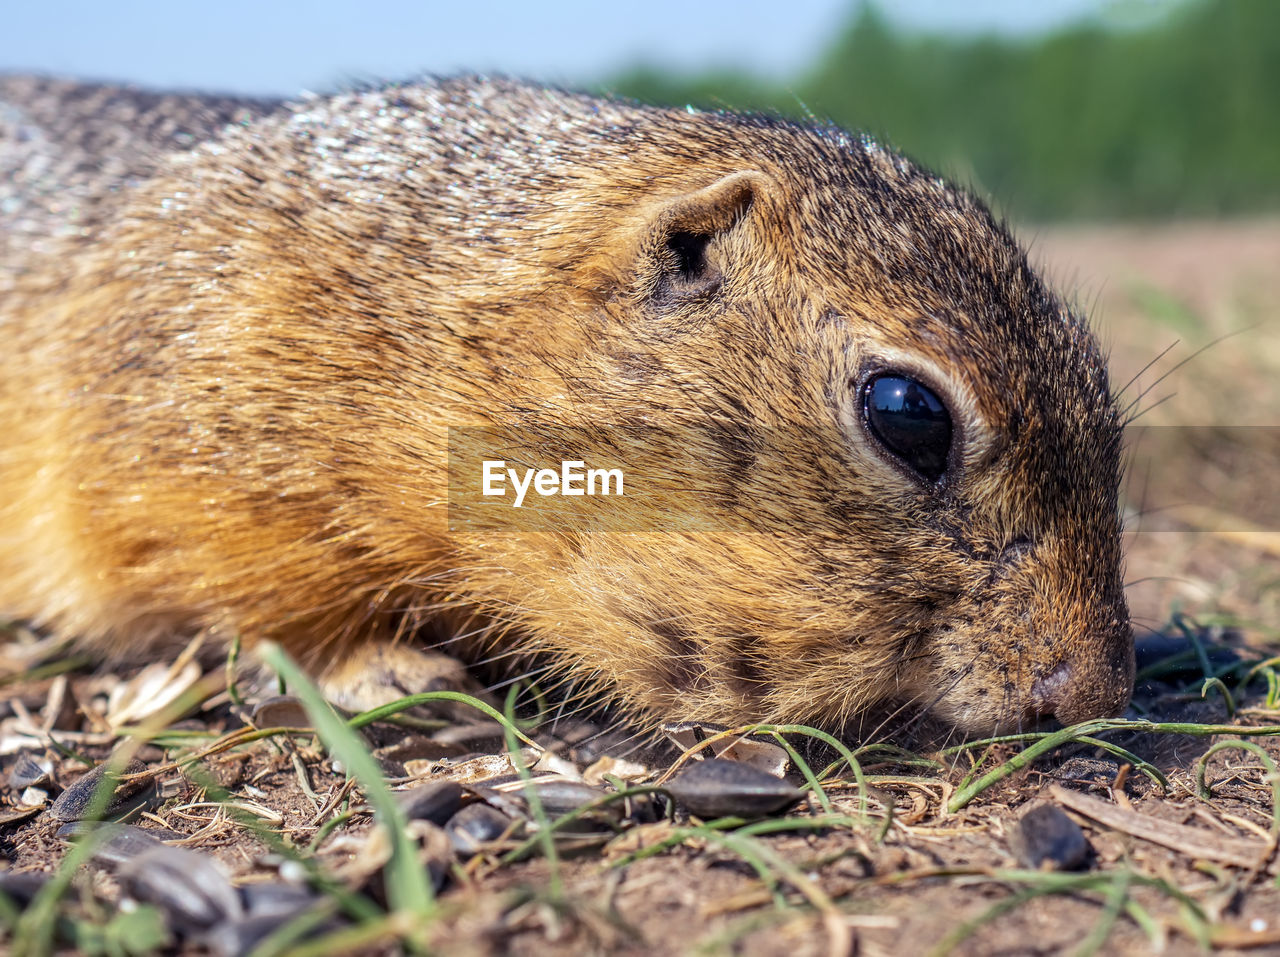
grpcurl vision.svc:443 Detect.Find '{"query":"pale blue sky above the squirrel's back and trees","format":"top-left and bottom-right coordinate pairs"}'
top-left (0, 0), bottom-right (1141, 95)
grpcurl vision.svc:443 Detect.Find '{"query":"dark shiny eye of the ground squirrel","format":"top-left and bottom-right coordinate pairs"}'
top-left (863, 372), bottom-right (951, 482)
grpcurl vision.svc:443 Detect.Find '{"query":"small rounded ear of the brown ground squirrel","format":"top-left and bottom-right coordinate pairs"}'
top-left (645, 171), bottom-right (769, 302)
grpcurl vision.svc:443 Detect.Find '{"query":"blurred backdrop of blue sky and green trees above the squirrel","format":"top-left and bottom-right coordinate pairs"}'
top-left (10, 0), bottom-right (1280, 220)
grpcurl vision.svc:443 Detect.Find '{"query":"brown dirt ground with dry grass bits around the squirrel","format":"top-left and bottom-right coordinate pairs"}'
top-left (0, 221), bottom-right (1280, 957)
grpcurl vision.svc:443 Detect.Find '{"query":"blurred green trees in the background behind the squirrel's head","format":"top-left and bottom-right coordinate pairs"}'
top-left (608, 0), bottom-right (1280, 219)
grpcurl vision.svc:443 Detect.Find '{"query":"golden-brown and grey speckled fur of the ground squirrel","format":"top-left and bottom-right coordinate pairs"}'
top-left (0, 78), bottom-right (1133, 731)
